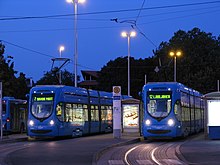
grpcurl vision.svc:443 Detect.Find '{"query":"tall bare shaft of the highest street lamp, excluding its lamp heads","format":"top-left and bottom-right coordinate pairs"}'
top-left (74, 1), bottom-right (78, 87)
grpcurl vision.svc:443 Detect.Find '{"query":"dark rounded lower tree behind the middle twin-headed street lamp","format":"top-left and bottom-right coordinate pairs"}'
top-left (97, 57), bottom-right (154, 97)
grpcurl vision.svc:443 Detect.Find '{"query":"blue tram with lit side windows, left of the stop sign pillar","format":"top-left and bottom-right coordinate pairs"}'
top-left (27, 85), bottom-right (122, 137)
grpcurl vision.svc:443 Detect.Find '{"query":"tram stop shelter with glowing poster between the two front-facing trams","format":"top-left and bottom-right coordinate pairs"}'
top-left (122, 98), bottom-right (140, 133)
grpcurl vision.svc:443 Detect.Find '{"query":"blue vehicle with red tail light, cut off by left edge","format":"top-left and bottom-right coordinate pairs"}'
top-left (2, 97), bottom-right (27, 134)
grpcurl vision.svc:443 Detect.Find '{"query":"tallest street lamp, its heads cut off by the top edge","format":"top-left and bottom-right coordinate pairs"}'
top-left (66, 0), bottom-right (85, 87)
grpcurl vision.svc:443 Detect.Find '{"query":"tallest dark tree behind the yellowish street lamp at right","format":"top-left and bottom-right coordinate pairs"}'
top-left (155, 28), bottom-right (220, 93)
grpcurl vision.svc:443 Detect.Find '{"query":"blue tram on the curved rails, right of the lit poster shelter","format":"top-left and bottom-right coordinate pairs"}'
top-left (141, 82), bottom-right (205, 139)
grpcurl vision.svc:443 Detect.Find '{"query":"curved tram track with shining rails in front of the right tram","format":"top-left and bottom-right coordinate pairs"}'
top-left (97, 141), bottom-right (187, 165)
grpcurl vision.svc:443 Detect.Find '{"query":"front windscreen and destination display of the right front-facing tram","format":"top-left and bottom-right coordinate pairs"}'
top-left (147, 92), bottom-right (171, 118)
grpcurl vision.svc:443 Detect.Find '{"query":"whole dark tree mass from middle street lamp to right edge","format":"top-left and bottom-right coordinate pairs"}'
top-left (98, 28), bottom-right (220, 97)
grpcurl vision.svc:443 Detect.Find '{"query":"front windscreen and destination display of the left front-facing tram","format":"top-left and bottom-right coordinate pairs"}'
top-left (31, 96), bottom-right (53, 118)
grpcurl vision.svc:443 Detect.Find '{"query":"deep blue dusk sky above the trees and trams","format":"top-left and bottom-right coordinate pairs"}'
top-left (0, 0), bottom-right (220, 81)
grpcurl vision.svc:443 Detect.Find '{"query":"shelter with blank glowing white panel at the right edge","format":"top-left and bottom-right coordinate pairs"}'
top-left (204, 91), bottom-right (220, 139)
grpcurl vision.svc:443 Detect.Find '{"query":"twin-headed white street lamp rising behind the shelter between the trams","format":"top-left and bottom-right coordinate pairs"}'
top-left (121, 31), bottom-right (136, 96)
